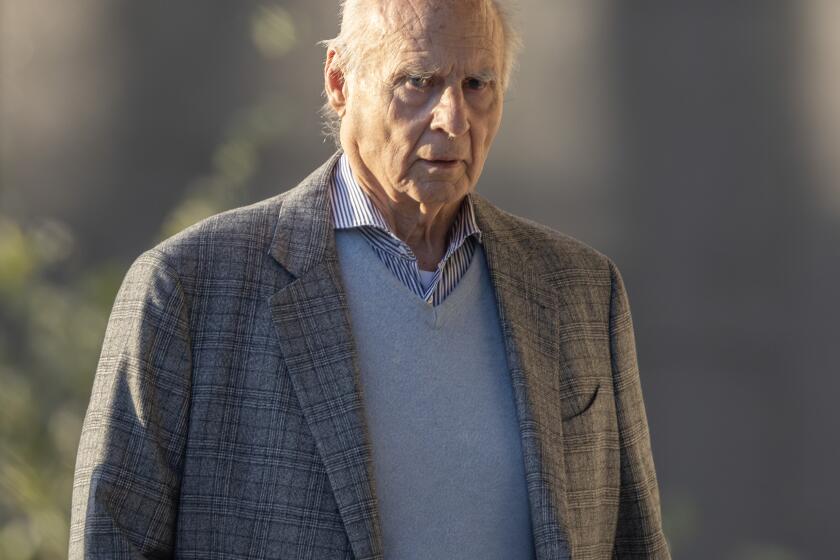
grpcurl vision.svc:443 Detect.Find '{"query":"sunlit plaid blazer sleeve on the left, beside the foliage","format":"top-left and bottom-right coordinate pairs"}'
top-left (69, 250), bottom-right (191, 559)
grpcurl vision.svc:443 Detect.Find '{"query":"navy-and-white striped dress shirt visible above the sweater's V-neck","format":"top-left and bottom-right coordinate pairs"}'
top-left (330, 154), bottom-right (481, 305)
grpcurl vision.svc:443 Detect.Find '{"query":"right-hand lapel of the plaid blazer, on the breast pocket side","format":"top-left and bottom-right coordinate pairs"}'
top-left (471, 194), bottom-right (570, 560)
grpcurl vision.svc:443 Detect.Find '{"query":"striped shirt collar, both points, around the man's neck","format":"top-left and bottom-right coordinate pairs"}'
top-left (330, 154), bottom-right (481, 252)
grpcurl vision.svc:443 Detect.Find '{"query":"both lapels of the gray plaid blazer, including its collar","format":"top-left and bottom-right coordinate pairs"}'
top-left (269, 151), bottom-right (568, 560)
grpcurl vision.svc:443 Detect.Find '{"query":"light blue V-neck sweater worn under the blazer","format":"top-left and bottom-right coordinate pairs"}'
top-left (335, 229), bottom-right (534, 560)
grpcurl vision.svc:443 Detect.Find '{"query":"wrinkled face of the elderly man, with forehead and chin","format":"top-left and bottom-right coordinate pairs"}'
top-left (334, 0), bottom-right (504, 205)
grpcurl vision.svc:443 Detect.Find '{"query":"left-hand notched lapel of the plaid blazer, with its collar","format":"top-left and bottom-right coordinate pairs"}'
top-left (269, 153), bottom-right (382, 559)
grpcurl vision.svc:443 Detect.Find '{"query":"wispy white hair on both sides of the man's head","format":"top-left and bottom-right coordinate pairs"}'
top-left (320, 0), bottom-right (522, 146)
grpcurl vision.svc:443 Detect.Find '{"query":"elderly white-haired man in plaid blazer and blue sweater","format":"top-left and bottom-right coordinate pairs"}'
top-left (70, 0), bottom-right (669, 560)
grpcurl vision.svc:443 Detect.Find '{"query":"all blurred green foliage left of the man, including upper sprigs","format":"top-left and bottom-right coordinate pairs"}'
top-left (0, 5), bottom-right (298, 560)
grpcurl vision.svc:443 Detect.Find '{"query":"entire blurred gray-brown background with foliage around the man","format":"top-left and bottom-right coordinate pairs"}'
top-left (0, 0), bottom-right (840, 560)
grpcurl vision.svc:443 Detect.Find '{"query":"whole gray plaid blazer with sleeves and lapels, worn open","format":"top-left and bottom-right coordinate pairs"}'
top-left (70, 154), bottom-right (669, 560)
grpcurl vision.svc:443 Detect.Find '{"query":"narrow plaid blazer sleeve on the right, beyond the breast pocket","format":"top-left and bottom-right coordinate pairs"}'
top-left (610, 262), bottom-right (671, 559)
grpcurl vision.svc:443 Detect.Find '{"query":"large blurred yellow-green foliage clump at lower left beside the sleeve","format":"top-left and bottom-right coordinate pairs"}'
top-left (0, 216), bottom-right (118, 559)
